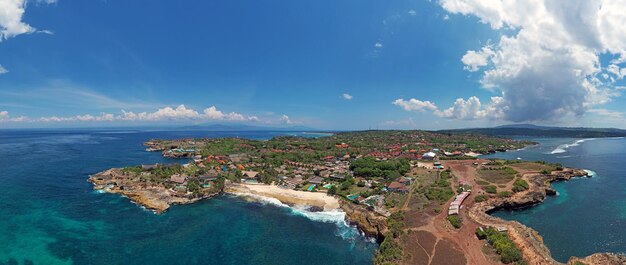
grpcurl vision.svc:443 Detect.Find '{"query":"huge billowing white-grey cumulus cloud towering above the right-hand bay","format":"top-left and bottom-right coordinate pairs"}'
top-left (439, 0), bottom-right (626, 122)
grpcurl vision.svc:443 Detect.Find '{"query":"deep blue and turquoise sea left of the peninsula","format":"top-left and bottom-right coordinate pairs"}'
top-left (0, 130), bottom-right (376, 264)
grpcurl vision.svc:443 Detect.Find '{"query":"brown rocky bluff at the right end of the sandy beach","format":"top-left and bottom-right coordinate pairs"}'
top-left (341, 201), bottom-right (389, 242)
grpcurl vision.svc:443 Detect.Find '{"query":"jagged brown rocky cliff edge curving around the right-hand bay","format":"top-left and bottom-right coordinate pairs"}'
top-left (468, 169), bottom-right (626, 265)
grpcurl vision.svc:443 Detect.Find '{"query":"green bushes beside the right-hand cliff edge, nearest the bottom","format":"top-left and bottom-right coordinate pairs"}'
top-left (476, 227), bottom-right (522, 264)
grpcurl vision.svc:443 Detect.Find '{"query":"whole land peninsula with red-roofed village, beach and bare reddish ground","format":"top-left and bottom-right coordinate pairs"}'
top-left (90, 131), bottom-right (611, 264)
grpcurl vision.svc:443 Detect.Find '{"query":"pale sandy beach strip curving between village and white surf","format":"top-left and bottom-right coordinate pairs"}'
top-left (224, 183), bottom-right (339, 211)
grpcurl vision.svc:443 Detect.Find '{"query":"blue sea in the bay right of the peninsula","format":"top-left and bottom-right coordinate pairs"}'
top-left (486, 138), bottom-right (626, 262)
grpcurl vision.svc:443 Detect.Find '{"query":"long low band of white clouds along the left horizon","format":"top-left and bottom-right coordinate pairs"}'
top-left (0, 105), bottom-right (259, 122)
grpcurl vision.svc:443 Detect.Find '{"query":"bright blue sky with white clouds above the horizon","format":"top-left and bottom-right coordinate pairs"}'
top-left (0, 0), bottom-right (626, 130)
